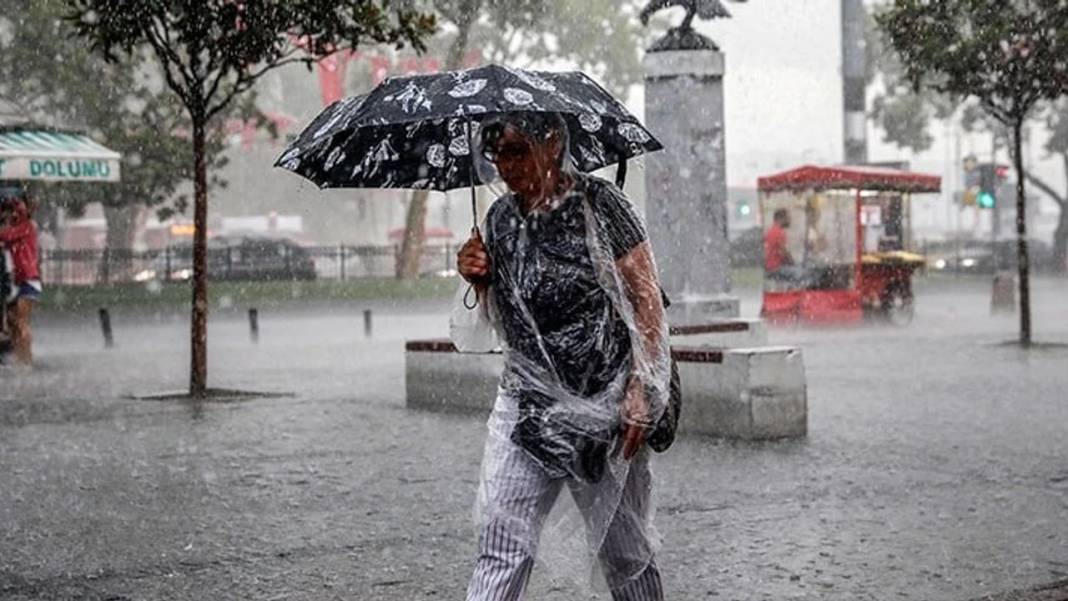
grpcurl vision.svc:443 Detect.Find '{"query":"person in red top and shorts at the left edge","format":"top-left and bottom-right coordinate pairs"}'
top-left (0, 194), bottom-right (42, 366)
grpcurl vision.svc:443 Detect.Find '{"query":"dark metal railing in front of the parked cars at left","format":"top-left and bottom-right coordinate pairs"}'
top-left (40, 244), bottom-right (458, 286)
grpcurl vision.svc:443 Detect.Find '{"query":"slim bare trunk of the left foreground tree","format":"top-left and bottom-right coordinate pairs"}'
top-left (189, 115), bottom-right (207, 398)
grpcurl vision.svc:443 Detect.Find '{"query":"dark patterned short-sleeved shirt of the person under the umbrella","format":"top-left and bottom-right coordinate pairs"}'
top-left (485, 175), bottom-right (646, 404)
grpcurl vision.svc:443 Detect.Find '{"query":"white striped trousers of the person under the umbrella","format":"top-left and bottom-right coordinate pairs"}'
top-left (467, 437), bottom-right (663, 601)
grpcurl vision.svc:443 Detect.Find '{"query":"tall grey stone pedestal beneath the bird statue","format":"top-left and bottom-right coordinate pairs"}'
top-left (644, 46), bottom-right (738, 326)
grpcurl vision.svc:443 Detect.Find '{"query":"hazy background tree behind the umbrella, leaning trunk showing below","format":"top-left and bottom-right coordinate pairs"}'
top-left (388, 0), bottom-right (645, 278)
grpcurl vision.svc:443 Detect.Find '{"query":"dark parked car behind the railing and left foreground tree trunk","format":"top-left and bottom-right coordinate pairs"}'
top-left (135, 237), bottom-right (315, 281)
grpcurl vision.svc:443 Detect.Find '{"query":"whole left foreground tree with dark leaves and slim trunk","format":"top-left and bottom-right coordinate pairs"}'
top-left (68, 0), bottom-right (435, 398)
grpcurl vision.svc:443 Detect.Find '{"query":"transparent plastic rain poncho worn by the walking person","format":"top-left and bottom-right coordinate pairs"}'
top-left (451, 114), bottom-right (671, 588)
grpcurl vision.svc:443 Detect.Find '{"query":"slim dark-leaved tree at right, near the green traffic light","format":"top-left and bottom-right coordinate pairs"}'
top-left (876, 0), bottom-right (1068, 347)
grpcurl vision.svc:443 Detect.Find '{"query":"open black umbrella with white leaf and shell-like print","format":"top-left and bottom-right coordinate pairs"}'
top-left (274, 65), bottom-right (663, 226)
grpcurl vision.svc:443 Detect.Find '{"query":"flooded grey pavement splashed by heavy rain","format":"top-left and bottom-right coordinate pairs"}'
top-left (0, 280), bottom-right (1068, 600)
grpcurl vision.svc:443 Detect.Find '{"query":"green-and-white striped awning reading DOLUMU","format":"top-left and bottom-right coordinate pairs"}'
top-left (0, 128), bottom-right (122, 181)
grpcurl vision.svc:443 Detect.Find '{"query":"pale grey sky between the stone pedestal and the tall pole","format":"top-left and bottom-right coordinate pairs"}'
top-left (698, 0), bottom-right (842, 186)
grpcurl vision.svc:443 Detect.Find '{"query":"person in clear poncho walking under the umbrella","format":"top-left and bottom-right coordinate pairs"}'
top-left (453, 112), bottom-right (671, 601)
